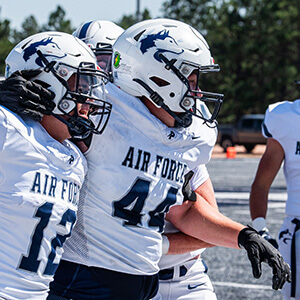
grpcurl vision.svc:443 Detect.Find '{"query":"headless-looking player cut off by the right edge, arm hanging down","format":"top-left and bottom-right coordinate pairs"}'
top-left (250, 100), bottom-right (300, 300)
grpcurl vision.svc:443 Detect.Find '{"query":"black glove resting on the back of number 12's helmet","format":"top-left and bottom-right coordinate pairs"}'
top-left (0, 69), bottom-right (55, 121)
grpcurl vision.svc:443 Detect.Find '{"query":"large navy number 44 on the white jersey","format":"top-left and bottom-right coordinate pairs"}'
top-left (113, 178), bottom-right (178, 232)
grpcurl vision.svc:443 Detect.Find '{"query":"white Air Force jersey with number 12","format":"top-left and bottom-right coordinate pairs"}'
top-left (0, 106), bottom-right (87, 300)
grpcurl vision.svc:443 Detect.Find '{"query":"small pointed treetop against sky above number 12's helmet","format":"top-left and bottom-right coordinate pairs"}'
top-left (42, 5), bottom-right (75, 33)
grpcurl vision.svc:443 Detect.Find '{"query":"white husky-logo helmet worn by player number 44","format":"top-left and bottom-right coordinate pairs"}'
top-left (113, 19), bottom-right (224, 127)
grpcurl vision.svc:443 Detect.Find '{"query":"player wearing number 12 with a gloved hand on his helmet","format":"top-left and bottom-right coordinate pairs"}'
top-left (0, 32), bottom-right (110, 300)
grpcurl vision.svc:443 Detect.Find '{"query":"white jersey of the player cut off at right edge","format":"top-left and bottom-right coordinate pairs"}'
top-left (262, 100), bottom-right (300, 217)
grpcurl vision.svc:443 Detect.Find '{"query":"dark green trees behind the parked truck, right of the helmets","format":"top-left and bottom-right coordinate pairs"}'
top-left (163, 0), bottom-right (300, 122)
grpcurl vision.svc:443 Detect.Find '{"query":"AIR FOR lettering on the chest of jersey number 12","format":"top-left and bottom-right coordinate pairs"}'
top-left (30, 172), bottom-right (80, 206)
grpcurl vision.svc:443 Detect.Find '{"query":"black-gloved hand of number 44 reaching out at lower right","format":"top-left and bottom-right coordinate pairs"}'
top-left (238, 227), bottom-right (291, 290)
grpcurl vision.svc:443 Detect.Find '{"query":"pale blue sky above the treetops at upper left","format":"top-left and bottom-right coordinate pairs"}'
top-left (0, 0), bottom-right (164, 29)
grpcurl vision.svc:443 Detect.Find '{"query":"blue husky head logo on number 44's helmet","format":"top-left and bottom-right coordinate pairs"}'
top-left (140, 29), bottom-right (184, 62)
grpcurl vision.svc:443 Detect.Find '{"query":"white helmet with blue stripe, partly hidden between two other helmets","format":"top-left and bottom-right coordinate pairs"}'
top-left (73, 20), bottom-right (124, 79)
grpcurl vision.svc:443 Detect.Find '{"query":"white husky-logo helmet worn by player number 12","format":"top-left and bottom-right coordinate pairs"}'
top-left (5, 32), bottom-right (111, 138)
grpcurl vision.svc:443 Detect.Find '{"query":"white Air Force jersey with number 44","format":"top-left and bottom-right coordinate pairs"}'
top-left (63, 85), bottom-right (216, 275)
